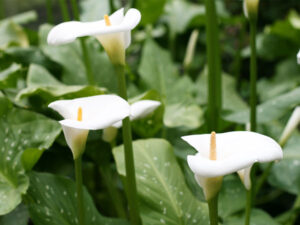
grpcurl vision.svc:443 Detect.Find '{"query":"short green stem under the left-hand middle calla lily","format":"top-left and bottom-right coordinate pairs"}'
top-left (74, 156), bottom-right (85, 225)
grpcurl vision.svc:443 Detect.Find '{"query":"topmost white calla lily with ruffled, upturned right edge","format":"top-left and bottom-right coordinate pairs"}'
top-left (48, 8), bottom-right (141, 65)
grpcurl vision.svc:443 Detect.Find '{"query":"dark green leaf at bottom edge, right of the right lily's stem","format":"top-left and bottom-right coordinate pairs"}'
top-left (224, 209), bottom-right (279, 225)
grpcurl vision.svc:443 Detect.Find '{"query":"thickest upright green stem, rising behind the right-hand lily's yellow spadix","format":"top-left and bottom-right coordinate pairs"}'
top-left (205, 0), bottom-right (222, 131)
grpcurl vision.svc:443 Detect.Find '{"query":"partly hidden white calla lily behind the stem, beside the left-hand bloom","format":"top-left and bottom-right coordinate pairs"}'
top-left (102, 100), bottom-right (161, 142)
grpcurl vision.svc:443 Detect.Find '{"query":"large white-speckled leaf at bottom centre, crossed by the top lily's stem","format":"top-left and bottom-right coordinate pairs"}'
top-left (113, 139), bottom-right (208, 225)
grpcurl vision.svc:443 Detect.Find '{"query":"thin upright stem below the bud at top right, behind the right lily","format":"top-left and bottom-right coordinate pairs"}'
top-left (250, 20), bottom-right (257, 131)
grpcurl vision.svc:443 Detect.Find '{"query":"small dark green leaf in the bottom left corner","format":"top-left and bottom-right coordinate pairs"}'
top-left (0, 204), bottom-right (29, 225)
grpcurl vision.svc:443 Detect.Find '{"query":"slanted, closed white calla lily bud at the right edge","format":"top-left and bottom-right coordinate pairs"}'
top-left (279, 106), bottom-right (300, 146)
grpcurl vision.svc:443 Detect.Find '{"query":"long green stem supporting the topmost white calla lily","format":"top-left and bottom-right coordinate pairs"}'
top-left (115, 65), bottom-right (141, 225)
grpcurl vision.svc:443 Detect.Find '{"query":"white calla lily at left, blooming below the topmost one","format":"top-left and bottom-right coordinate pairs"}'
top-left (49, 95), bottom-right (130, 159)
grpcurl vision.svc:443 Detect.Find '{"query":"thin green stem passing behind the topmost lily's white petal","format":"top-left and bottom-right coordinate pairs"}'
top-left (71, 0), bottom-right (95, 85)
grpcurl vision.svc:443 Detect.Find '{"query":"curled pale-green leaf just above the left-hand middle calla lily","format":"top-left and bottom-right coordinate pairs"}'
top-left (17, 64), bottom-right (104, 105)
